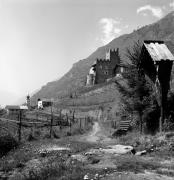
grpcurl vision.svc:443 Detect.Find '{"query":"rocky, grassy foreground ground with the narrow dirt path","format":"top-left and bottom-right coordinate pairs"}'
top-left (0, 122), bottom-right (174, 180)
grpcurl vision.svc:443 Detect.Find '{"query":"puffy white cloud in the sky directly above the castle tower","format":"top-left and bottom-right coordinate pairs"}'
top-left (99, 18), bottom-right (122, 45)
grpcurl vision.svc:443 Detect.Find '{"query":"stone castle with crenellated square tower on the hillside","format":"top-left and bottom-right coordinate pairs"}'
top-left (86, 48), bottom-right (123, 86)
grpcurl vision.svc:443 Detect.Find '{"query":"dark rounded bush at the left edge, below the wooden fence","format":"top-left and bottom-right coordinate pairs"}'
top-left (0, 135), bottom-right (18, 157)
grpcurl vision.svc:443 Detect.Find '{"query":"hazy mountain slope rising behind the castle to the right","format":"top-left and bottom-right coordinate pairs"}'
top-left (33, 12), bottom-right (174, 99)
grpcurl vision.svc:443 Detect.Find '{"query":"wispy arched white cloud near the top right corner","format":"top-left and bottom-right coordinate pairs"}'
top-left (137, 5), bottom-right (163, 18)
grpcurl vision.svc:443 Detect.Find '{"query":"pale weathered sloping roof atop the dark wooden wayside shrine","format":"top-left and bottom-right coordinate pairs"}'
top-left (144, 41), bottom-right (174, 61)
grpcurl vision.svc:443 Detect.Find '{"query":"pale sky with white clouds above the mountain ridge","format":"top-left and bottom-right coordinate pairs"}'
top-left (0, 0), bottom-right (174, 104)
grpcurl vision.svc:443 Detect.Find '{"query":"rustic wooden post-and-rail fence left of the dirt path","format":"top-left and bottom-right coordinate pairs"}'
top-left (0, 111), bottom-right (91, 141)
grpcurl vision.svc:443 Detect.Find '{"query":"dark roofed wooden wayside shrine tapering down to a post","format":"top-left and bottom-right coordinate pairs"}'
top-left (140, 40), bottom-right (174, 131)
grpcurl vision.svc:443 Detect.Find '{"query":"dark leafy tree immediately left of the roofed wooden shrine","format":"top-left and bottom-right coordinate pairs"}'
top-left (116, 42), bottom-right (152, 133)
